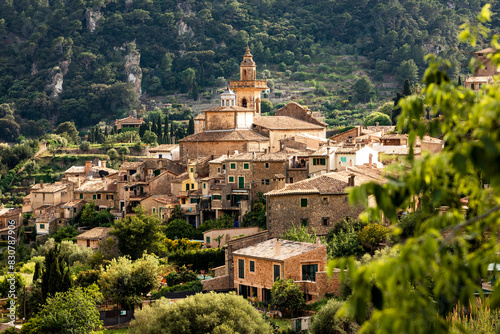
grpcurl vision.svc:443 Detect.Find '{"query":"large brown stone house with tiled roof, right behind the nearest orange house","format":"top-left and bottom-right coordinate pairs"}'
top-left (265, 166), bottom-right (382, 237)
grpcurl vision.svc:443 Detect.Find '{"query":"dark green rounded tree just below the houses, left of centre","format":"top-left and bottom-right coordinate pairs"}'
top-left (110, 207), bottom-right (164, 259)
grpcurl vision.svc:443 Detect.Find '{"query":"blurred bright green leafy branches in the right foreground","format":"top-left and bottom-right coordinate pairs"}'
top-left (329, 13), bottom-right (500, 333)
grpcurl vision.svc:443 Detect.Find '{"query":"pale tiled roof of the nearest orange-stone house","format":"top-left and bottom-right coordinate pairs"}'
top-left (233, 238), bottom-right (326, 261)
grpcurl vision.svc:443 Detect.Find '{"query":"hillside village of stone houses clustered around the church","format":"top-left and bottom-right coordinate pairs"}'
top-left (0, 47), bottom-right (497, 334)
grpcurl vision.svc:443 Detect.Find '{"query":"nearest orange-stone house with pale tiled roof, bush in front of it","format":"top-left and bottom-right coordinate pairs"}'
top-left (233, 238), bottom-right (340, 302)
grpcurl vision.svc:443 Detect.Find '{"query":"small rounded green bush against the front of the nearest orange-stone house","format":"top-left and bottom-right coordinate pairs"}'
top-left (271, 279), bottom-right (306, 317)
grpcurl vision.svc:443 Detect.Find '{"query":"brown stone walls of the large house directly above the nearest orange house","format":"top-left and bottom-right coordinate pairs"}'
top-left (267, 194), bottom-right (364, 238)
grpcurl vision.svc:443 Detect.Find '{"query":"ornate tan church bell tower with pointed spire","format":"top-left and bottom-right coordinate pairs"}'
top-left (229, 46), bottom-right (269, 115)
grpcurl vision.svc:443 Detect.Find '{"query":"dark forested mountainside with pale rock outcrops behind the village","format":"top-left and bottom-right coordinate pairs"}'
top-left (0, 0), bottom-right (499, 139)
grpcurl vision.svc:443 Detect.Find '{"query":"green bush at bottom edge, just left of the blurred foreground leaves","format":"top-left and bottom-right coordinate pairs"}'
top-left (310, 299), bottom-right (359, 334)
